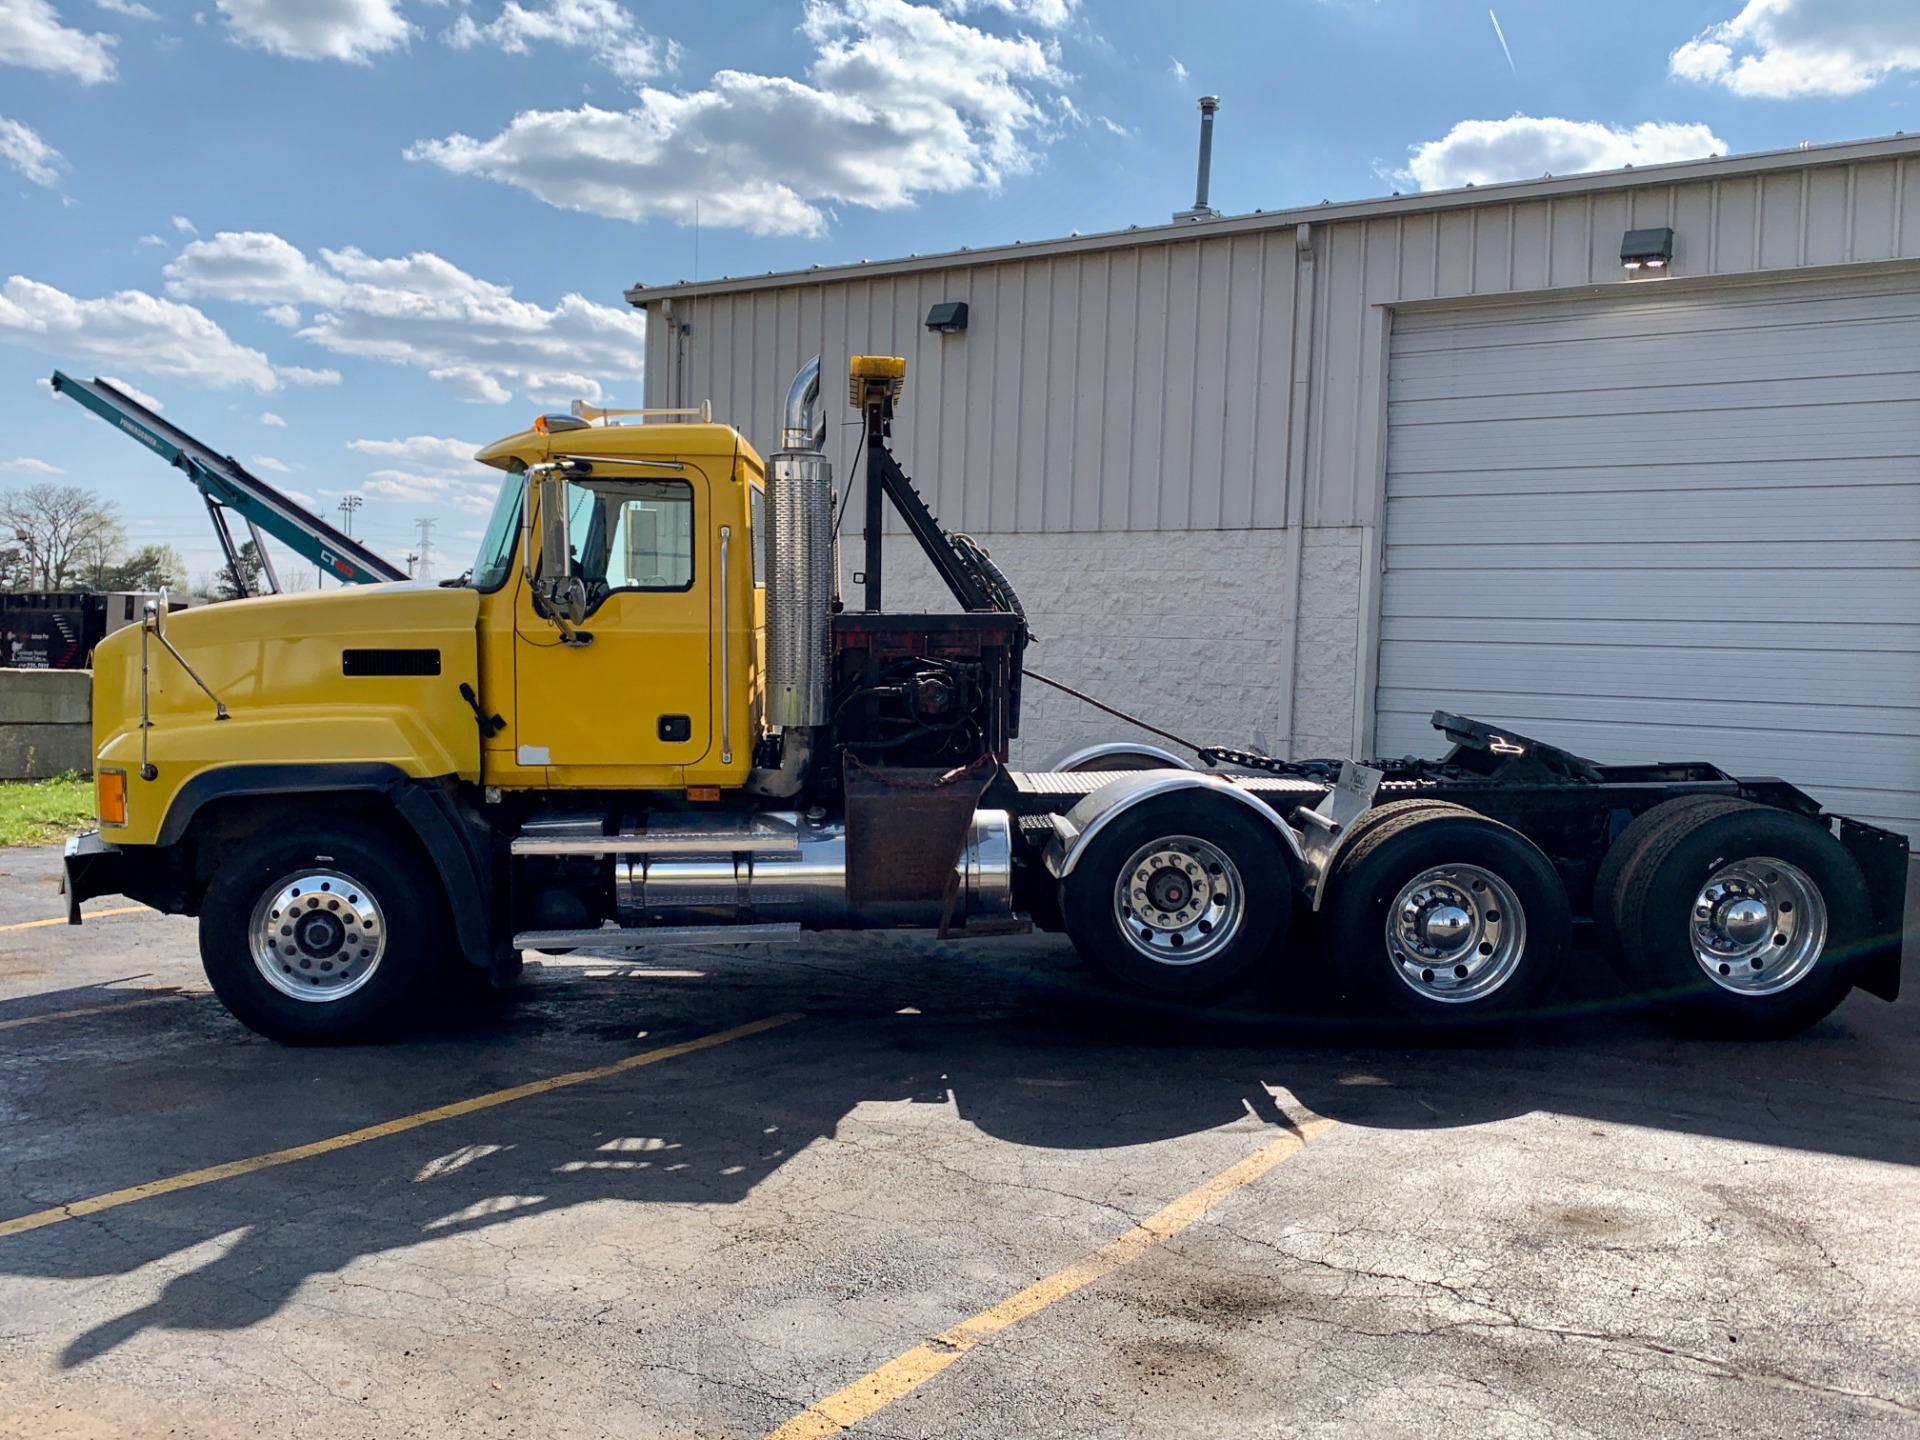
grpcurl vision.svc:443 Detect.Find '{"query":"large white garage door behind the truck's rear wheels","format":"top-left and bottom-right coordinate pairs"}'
top-left (1377, 275), bottom-right (1920, 837)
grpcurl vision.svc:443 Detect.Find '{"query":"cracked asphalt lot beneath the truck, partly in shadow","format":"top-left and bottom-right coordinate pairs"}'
top-left (0, 851), bottom-right (1920, 1440)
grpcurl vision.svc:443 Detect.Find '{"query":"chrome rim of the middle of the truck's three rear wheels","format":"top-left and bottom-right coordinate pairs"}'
top-left (1386, 866), bottom-right (1526, 1004)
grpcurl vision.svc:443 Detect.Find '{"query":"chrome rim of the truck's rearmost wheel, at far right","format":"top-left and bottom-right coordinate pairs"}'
top-left (1692, 854), bottom-right (1826, 995)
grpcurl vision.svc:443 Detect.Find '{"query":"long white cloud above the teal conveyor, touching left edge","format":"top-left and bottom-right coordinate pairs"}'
top-left (0, 275), bottom-right (280, 390)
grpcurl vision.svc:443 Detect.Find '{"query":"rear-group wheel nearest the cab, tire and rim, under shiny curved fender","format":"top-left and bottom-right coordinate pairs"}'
top-left (1060, 793), bottom-right (1294, 1000)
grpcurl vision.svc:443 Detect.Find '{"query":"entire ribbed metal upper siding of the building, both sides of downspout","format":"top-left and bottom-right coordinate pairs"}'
top-left (647, 159), bottom-right (1920, 532)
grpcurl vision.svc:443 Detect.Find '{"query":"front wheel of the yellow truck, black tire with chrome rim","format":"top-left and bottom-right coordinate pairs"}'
top-left (200, 820), bottom-right (445, 1044)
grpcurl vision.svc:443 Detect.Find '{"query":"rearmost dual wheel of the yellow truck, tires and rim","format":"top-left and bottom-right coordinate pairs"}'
top-left (1611, 801), bottom-right (1872, 1039)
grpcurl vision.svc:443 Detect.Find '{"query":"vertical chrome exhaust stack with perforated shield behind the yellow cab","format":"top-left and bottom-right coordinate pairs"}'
top-left (747, 355), bottom-right (835, 797)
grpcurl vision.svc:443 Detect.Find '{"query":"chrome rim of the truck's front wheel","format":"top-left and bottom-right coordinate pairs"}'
top-left (248, 870), bottom-right (386, 1004)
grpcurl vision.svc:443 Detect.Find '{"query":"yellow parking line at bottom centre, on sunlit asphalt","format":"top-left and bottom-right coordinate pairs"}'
top-left (768, 1119), bottom-right (1338, 1440)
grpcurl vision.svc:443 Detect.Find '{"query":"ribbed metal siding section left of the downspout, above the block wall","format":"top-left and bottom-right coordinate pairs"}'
top-left (647, 232), bottom-right (1294, 534)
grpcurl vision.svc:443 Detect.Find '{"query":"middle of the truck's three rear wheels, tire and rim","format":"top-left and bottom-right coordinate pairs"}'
top-left (1321, 801), bottom-right (1571, 1029)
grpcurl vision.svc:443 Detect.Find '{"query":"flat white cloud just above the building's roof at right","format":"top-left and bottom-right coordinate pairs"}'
top-left (1396, 115), bottom-right (1726, 190)
